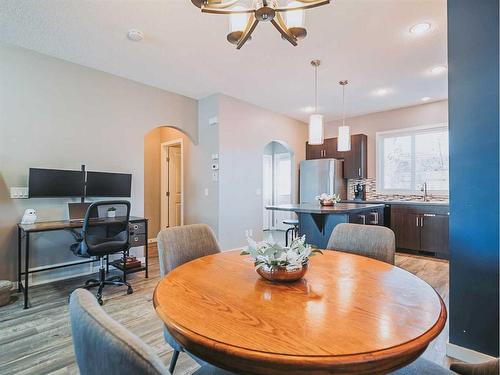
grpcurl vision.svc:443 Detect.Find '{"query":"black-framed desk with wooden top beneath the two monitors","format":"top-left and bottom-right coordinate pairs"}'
top-left (17, 216), bottom-right (148, 309)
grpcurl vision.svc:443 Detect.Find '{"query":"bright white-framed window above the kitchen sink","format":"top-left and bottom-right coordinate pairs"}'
top-left (377, 124), bottom-right (449, 195)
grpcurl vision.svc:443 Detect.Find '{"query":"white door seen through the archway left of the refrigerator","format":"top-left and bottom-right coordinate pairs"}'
top-left (273, 153), bottom-right (292, 230)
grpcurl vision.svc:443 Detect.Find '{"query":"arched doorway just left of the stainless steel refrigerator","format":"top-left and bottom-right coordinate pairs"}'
top-left (262, 141), bottom-right (294, 237)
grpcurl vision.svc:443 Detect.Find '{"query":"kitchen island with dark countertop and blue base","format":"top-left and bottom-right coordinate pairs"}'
top-left (266, 203), bottom-right (385, 249)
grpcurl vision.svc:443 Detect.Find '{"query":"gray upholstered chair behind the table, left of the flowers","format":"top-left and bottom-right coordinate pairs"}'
top-left (157, 224), bottom-right (220, 373)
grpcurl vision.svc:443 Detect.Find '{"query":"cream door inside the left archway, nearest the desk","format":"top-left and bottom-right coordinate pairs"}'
top-left (167, 146), bottom-right (182, 227)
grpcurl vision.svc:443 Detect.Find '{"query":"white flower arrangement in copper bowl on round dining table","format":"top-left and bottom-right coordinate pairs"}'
top-left (241, 236), bottom-right (322, 282)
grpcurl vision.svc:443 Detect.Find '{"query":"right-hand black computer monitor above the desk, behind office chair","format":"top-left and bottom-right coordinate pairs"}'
top-left (85, 172), bottom-right (132, 197)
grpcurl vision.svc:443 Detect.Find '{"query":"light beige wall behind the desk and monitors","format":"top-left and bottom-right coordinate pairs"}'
top-left (0, 44), bottom-right (198, 280)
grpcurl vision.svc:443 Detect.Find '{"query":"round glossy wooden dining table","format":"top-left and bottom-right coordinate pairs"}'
top-left (154, 250), bottom-right (447, 375)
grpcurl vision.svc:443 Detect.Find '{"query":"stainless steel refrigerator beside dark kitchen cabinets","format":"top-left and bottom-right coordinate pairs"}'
top-left (300, 159), bottom-right (347, 203)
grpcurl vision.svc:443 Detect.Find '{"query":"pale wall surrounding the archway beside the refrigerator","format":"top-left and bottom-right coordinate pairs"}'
top-left (219, 95), bottom-right (307, 249)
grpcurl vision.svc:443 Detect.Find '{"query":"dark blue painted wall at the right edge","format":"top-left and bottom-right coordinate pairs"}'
top-left (448, 0), bottom-right (499, 357)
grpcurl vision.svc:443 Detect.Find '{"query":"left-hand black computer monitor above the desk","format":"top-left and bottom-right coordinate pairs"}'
top-left (28, 168), bottom-right (85, 198)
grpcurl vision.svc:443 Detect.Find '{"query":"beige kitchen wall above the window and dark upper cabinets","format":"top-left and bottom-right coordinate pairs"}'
top-left (325, 100), bottom-right (448, 178)
